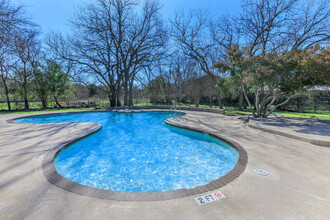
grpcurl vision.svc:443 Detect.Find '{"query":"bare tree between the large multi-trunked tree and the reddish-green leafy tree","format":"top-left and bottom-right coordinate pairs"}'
top-left (171, 10), bottom-right (228, 106)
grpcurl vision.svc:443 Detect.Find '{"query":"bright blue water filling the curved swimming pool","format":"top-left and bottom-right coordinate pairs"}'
top-left (16, 112), bottom-right (238, 192)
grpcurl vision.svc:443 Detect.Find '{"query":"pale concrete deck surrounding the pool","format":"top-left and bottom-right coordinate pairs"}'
top-left (0, 112), bottom-right (330, 219)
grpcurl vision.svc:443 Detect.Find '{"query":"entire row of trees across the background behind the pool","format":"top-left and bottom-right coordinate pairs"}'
top-left (0, 0), bottom-right (330, 117)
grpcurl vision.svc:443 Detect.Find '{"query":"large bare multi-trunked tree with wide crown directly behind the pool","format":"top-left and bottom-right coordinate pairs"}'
top-left (48, 0), bottom-right (164, 106)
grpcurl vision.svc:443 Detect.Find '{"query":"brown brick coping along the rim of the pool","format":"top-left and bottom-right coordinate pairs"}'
top-left (10, 111), bottom-right (248, 202)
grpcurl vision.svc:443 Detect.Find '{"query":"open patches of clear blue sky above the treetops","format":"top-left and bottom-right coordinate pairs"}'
top-left (10, 0), bottom-right (240, 33)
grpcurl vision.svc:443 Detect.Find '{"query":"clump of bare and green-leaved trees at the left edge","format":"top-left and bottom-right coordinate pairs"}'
top-left (0, 0), bottom-right (69, 110)
